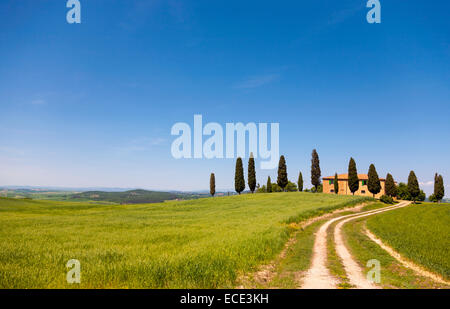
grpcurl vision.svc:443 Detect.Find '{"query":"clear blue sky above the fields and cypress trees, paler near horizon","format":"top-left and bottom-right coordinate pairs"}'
top-left (0, 0), bottom-right (450, 196)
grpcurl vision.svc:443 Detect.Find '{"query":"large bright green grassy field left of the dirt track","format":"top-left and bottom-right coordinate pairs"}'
top-left (0, 193), bottom-right (370, 288)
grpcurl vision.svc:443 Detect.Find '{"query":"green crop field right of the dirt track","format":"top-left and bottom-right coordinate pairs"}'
top-left (367, 203), bottom-right (450, 279)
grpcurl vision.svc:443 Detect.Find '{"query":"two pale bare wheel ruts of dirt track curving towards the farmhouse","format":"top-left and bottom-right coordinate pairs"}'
top-left (302, 202), bottom-right (410, 289)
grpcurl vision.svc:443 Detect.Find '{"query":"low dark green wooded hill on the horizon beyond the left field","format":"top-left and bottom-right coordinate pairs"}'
top-left (70, 189), bottom-right (186, 204)
